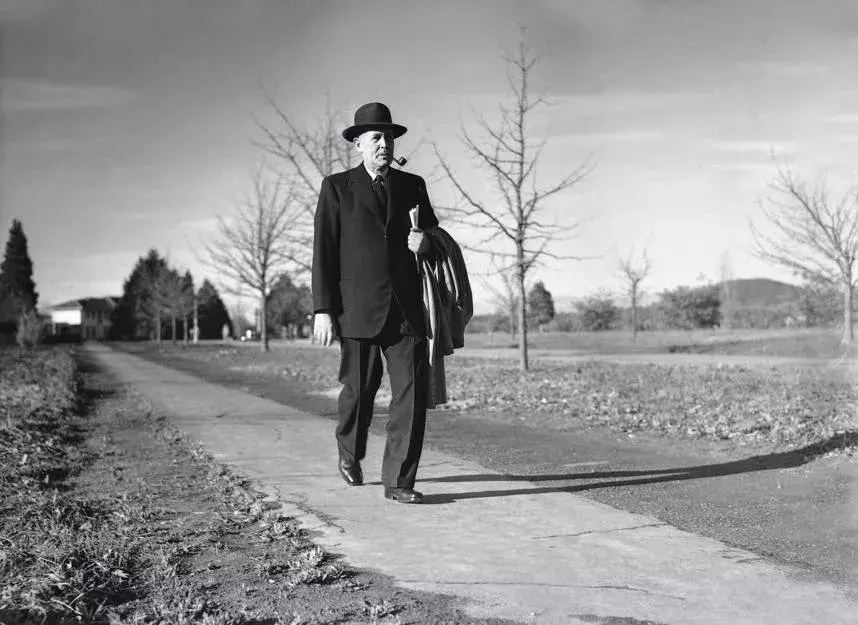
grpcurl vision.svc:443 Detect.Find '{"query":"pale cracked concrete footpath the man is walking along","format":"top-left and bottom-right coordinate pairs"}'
top-left (88, 344), bottom-right (858, 625)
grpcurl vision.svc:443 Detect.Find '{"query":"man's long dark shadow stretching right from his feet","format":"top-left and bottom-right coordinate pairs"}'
top-left (412, 431), bottom-right (858, 504)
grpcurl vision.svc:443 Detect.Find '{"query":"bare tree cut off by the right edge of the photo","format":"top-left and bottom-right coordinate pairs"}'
top-left (750, 165), bottom-right (858, 345)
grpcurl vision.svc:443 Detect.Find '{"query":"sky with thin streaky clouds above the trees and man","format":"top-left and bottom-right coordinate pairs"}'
top-left (0, 0), bottom-right (858, 310)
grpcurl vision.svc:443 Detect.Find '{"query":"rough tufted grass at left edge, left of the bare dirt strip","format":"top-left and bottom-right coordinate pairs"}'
top-left (0, 349), bottom-right (127, 622)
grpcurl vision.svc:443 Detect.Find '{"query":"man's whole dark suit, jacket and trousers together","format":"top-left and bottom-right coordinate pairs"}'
top-left (312, 164), bottom-right (438, 488)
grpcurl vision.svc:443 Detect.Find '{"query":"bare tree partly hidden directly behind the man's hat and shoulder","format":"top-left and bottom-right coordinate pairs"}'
top-left (255, 89), bottom-right (357, 273)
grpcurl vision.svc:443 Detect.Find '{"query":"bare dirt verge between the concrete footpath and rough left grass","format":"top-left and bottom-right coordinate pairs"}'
top-left (67, 352), bottom-right (520, 625)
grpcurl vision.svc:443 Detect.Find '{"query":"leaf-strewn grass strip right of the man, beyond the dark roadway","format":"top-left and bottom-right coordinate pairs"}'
top-left (444, 359), bottom-right (858, 448)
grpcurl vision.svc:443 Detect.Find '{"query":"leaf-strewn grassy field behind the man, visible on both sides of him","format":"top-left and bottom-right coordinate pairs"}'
top-left (120, 331), bottom-right (858, 449)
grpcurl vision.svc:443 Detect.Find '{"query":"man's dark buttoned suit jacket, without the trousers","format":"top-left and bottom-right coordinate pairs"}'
top-left (312, 164), bottom-right (438, 338)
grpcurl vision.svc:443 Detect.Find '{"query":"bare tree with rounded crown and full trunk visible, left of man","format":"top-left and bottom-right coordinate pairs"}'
top-left (204, 171), bottom-right (304, 351)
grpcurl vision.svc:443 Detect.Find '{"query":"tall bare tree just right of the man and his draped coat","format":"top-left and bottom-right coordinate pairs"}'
top-left (434, 33), bottom-right (592, 370)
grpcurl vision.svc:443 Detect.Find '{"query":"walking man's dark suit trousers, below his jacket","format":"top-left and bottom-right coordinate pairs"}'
top-left (336, 301), bottom-right (429, 488)
